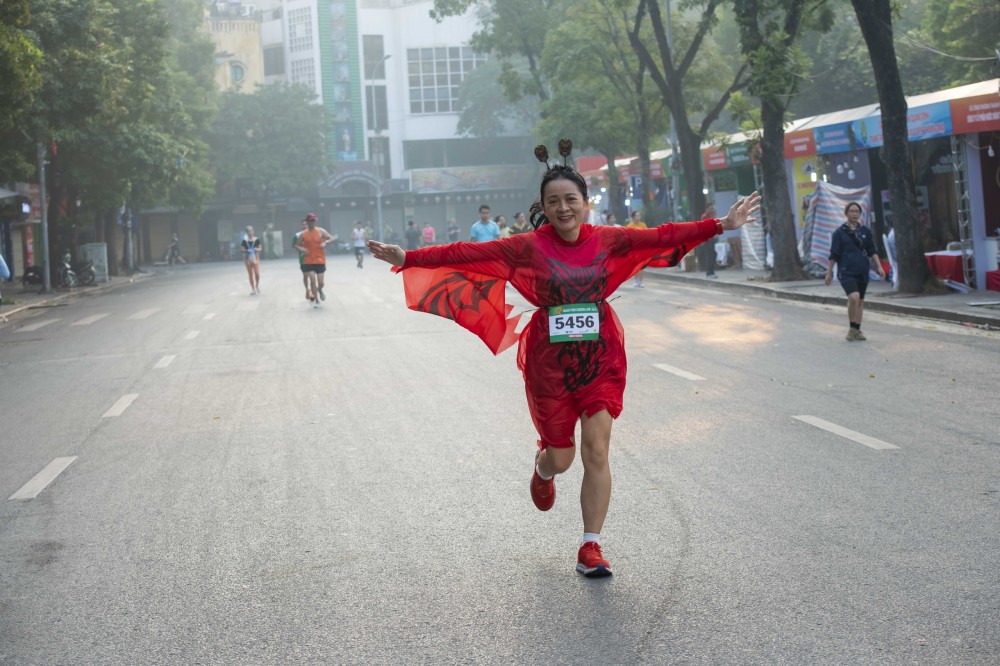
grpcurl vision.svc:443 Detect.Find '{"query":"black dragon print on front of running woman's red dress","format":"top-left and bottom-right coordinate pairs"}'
top-left (546, 253), bottom-right (608, 392)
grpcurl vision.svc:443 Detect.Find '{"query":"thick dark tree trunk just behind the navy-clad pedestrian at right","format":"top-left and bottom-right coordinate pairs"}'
top-left (851, 0), bottom-right (932, 294)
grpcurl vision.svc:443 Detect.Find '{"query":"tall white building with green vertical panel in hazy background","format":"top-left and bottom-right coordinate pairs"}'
top-left (261, 0), bottom-right (536, 237)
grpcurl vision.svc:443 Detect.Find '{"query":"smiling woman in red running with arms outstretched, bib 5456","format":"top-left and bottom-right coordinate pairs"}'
top-left (369, 142), bottom-right (760, 577)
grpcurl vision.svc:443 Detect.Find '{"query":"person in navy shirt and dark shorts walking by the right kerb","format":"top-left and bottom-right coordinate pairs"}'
top-left (825, 201), bottom-right (885, 342)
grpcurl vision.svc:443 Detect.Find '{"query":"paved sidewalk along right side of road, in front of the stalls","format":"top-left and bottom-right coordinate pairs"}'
top-left (644, 267), bottom-right (1000, 331)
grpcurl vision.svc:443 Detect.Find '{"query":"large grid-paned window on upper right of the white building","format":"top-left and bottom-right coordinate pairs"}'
top-left (406, 46), bottom-right (486, 114)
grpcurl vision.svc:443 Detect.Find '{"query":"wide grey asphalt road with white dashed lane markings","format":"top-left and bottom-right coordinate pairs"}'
top-left (0, 257), bottom-right (1000, 665)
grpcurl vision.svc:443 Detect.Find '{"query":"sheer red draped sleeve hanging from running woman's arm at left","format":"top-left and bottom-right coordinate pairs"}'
top-left (394, 234), bottom-right (530, 354)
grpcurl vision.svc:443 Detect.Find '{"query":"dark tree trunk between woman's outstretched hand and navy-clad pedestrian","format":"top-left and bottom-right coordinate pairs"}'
top-left (760, 99), bottom-right (809, 282)
